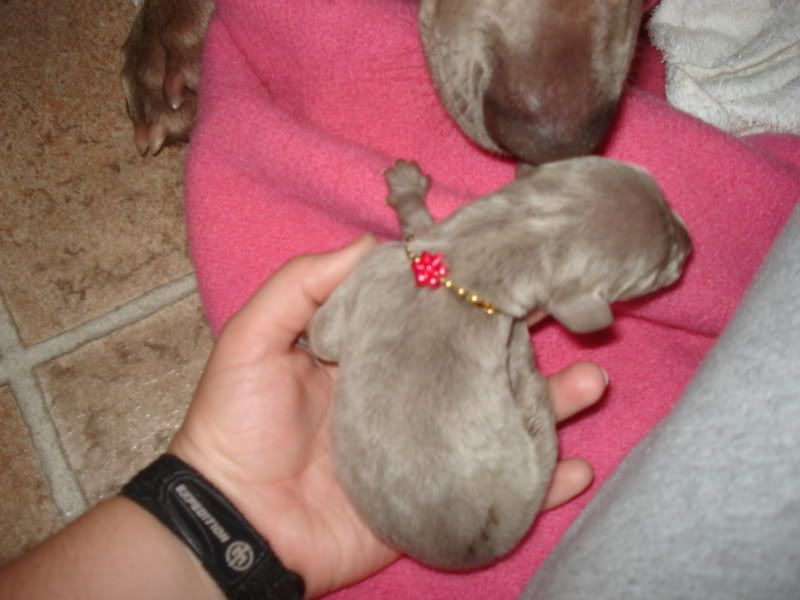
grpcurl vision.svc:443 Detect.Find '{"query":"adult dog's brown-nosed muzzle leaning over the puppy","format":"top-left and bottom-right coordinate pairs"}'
top-left (419, 0), bottom-right (642, 164)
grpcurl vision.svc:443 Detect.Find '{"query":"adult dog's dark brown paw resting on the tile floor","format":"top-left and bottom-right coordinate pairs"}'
top-left (121, 0), bottom-right (214, 155)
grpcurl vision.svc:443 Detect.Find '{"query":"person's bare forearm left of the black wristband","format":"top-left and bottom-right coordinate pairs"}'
top-left (0, 496), bottom-right (223, 600)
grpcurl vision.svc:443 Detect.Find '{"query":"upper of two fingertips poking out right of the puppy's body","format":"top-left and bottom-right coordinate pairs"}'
top-left (548, 361), bottom-right (608, 421)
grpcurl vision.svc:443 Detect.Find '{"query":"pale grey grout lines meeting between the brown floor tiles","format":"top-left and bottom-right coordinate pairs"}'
top-left (0, 273), bottom-right (197, 520)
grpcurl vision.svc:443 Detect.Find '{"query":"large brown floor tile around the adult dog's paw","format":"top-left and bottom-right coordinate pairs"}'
top-left (0, 0), bottom-right (190, 344)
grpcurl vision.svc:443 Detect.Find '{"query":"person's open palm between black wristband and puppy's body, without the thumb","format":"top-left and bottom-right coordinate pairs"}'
top-left (173, 340), bottom-right (396, 595)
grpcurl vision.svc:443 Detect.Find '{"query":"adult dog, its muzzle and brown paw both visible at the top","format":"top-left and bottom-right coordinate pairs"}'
top-left (122, 0), bottom-right (642, 157)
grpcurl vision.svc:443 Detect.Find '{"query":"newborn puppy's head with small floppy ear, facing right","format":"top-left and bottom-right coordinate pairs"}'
top-left (521, 157), bottom-right (691, 333)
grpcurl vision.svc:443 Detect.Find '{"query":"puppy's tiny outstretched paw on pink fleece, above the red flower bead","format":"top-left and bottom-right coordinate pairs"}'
top-left (384, 160), bottom-right (433, 237)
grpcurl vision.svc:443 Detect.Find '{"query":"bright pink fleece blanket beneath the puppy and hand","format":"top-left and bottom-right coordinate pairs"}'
top-left (186, 0), bottom-right (800, 600)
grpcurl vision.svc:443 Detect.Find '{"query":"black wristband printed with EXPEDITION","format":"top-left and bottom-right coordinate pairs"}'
top-left (121, 454), bottom-right (305, 600)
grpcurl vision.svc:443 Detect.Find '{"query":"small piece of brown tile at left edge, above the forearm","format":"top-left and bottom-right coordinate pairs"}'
top-left (0, 386), bottom-right (62, 563)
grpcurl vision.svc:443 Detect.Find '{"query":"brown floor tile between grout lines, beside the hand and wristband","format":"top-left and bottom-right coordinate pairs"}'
top-left (37, 297), bottom-right (211, 503)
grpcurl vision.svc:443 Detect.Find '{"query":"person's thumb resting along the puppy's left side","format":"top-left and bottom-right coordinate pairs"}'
top-left (220, 235), bottom-right (376, 355)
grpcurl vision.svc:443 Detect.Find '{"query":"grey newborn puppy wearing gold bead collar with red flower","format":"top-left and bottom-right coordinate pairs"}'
top-left (308, 157), bottom-right (690, 569)
